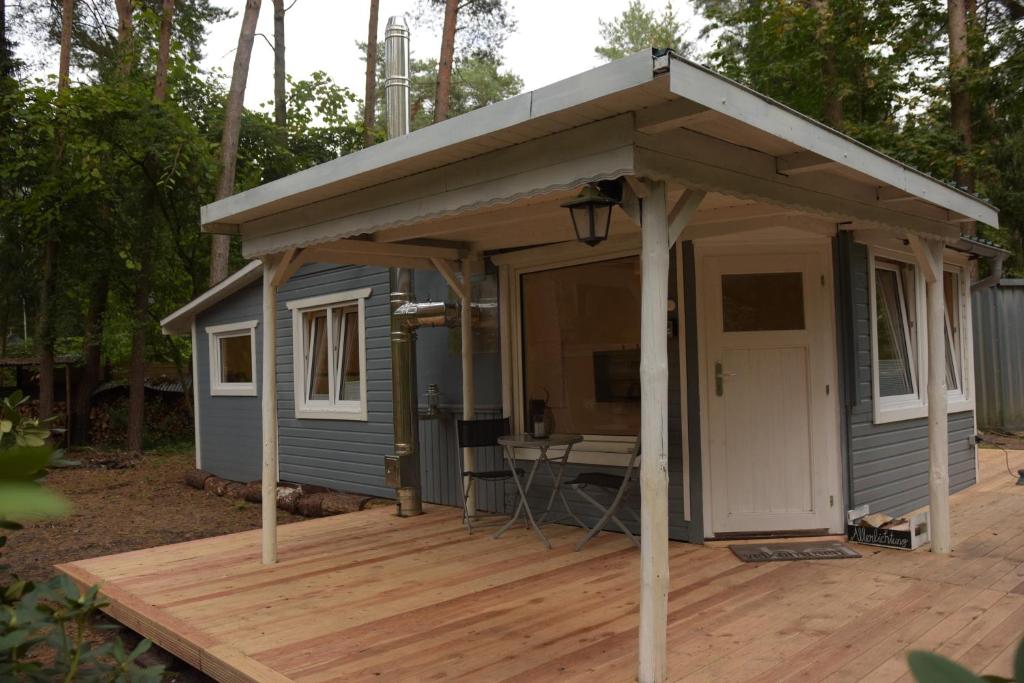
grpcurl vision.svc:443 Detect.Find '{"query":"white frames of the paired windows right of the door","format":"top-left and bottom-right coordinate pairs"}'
top-left (868, 245), bottom-right (975, 424)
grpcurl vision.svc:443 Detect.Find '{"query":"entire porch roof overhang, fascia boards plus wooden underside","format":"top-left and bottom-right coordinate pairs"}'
top-left (202, 51), bottom-right (998, 262)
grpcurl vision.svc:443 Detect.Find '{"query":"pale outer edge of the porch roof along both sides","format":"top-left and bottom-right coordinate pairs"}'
top-left (202, 50), bottom-right (998, 236)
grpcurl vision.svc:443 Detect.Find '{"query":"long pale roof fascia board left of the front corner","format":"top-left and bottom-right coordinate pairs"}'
top-left (201, 49), bottom-right (654, 231)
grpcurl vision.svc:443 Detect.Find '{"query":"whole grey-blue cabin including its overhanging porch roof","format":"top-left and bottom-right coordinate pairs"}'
top-left (164, 52), bottom-right (1005, 552)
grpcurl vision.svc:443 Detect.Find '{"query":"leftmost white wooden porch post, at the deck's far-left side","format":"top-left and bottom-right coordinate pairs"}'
top-left (260, 257), bottom-right (278, 564)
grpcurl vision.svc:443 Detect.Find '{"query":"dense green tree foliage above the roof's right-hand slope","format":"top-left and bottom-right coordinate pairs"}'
top-left (695, 0), bottom-right (1024, 273)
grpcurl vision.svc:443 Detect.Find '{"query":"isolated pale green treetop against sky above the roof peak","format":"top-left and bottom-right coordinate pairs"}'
top-left (594, 0), bottom-right (693, 61)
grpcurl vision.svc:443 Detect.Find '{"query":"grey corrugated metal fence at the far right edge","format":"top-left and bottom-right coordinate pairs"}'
top-left (971, 280), bottom-right (1024, 431)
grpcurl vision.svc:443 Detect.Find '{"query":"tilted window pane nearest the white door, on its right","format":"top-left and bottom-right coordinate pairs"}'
top-left (874, 260), bottom-right (914, 396)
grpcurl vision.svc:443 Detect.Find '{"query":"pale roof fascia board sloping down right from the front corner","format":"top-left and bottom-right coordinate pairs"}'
top-left (669, 55), bottom-right (999, 227)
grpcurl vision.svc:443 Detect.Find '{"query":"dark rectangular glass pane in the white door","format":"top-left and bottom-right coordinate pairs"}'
top-left (722, 272), bottom-right (804, 332)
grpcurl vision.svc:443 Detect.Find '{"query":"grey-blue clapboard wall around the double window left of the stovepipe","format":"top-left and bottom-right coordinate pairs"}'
top-left (274, 264), bottom-right (394, 498)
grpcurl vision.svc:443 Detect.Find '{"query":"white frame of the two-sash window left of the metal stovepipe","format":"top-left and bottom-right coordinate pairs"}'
top-left (287, 287), bottom-right (373, 422)
